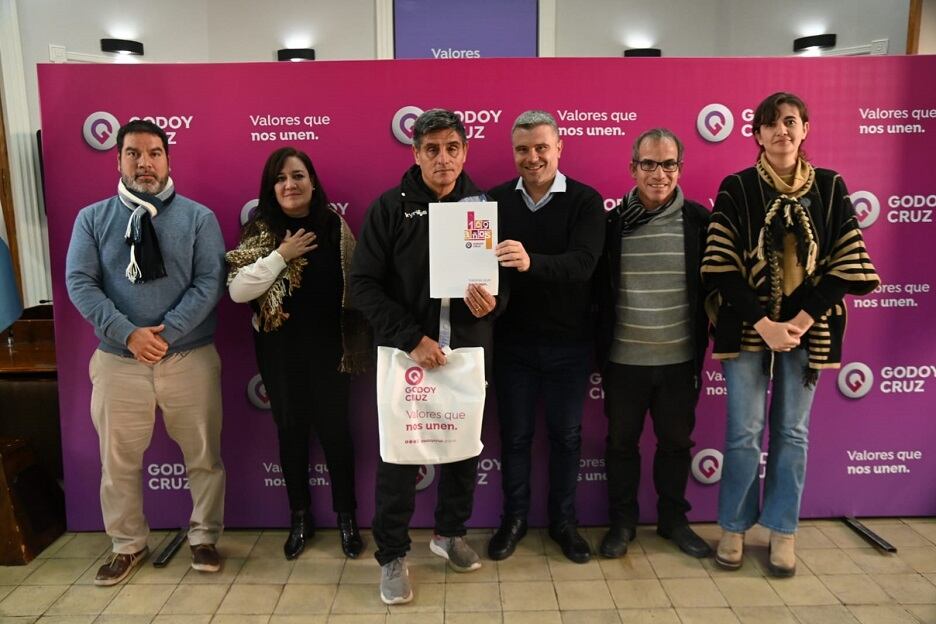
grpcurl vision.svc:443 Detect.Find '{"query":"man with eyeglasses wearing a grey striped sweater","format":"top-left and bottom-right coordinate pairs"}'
top-left (596, 128), bottom-right (712, 558)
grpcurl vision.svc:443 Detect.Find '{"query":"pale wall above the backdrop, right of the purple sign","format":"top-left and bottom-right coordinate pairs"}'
top-left (556, 0), bottom-right (909, 56)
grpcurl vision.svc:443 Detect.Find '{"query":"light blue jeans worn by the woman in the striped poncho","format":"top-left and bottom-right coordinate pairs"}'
top-left (718, 348), bottom-right (815, 533)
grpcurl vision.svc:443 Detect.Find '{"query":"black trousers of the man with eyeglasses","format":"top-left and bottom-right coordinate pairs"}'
top-left (602, 362), bottom-right (699, 531)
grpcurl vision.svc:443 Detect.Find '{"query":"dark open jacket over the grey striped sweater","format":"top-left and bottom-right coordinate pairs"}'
top-left (595, 199), bottom-right (711, 375)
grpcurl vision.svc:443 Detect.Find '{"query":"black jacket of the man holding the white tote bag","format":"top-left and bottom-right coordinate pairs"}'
top-left (350, 165), bottom-right (504, 376)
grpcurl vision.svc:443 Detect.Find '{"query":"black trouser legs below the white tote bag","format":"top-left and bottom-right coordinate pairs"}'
top-left (373, 457), bottom-right (478, 565)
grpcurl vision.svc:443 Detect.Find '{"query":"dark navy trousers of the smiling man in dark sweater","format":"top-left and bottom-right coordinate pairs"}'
top-left (494, 343), bottom-right (592, 530)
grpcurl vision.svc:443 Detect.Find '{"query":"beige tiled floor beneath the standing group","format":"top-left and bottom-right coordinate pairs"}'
top-left (0, 519), bottom-right (936, 624)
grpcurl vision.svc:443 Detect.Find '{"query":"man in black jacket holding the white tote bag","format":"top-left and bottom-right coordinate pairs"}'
top-left (350, 109), bottom-right (497, 604)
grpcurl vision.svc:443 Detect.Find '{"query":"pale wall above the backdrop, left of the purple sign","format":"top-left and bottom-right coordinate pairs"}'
top-left (17, 0), bottom-right (376, 129)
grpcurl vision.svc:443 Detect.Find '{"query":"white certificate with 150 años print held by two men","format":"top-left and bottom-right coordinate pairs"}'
top-left (429, 202), bottom-right (498, 299)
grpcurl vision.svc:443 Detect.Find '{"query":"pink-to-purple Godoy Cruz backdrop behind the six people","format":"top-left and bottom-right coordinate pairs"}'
top-left (39, 57), bottom-right (936, 530)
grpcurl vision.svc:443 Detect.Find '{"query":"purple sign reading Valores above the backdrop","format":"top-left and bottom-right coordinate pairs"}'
top-left (393, 0), bottom-right (539, 59)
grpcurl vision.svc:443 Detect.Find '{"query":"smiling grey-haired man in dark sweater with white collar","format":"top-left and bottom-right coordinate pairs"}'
top-left (488, 110), bottom-right (604, 563)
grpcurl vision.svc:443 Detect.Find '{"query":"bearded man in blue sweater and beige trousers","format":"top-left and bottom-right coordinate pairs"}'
top-left (65, 120), bottom-right (225, 585)
